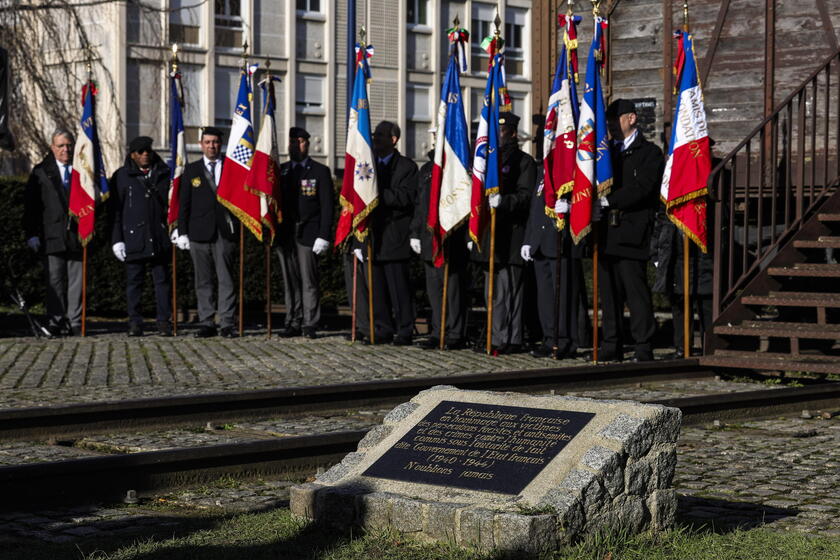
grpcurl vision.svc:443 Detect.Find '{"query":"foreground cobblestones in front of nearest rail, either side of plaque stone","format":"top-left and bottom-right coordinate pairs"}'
top-left (0, 416), bottom-right (840, 544)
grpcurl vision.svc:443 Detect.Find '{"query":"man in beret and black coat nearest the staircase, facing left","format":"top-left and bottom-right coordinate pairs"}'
top-left (593, 99), bottom-right (664, 361)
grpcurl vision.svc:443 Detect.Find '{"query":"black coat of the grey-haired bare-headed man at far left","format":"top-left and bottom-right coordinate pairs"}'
top-left (23, 154), bottom-right (82, 255)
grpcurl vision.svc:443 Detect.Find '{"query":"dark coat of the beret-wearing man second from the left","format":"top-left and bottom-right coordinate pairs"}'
top-left (108, 154), bottom-right (171, 262)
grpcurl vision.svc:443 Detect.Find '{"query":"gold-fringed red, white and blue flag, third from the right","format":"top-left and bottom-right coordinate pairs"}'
top-left (543, 14), bottom-right (581, 231)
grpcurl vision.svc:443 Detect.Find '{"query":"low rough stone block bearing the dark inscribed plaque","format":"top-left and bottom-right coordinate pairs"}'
top-left (291, 386), bottom-right (682, 553)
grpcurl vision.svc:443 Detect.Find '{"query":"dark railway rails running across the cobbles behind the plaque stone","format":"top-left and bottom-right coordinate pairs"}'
top-left (0, 360), bottom-right (840, 509)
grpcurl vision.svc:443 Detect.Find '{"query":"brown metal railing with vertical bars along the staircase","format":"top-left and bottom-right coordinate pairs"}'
top-left (708, 46), bottom-right (840, 318)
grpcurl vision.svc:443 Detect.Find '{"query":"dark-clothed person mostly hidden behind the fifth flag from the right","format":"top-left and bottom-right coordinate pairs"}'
top-left (410, 150), bottom-right (469, 350)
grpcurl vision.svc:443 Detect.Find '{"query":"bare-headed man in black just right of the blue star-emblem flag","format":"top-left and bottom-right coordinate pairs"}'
top-left (354, 121), bottom-right (417, 346)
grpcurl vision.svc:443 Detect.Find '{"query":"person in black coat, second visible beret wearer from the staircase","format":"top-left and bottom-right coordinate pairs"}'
top-left (473, 112), bottom-right (537, 354)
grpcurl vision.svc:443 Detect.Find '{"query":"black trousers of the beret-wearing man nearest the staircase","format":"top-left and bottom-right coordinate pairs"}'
top-left (598, 255), bottom-right (656, 359)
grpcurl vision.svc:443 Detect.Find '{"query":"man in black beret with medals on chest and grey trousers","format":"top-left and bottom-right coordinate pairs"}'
top-left (277, 126), bottom-right (335, 338)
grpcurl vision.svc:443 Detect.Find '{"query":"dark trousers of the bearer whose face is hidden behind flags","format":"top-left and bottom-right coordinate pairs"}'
top-left (534, 254), bottom-right (586, 352)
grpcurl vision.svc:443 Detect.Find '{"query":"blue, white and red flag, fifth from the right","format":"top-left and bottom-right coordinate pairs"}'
top-left (426, 29), bottom-right (472, 267)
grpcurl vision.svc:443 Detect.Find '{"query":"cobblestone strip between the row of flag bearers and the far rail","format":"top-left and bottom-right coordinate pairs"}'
top-left (0, 331), bottom-right (688, 408)
